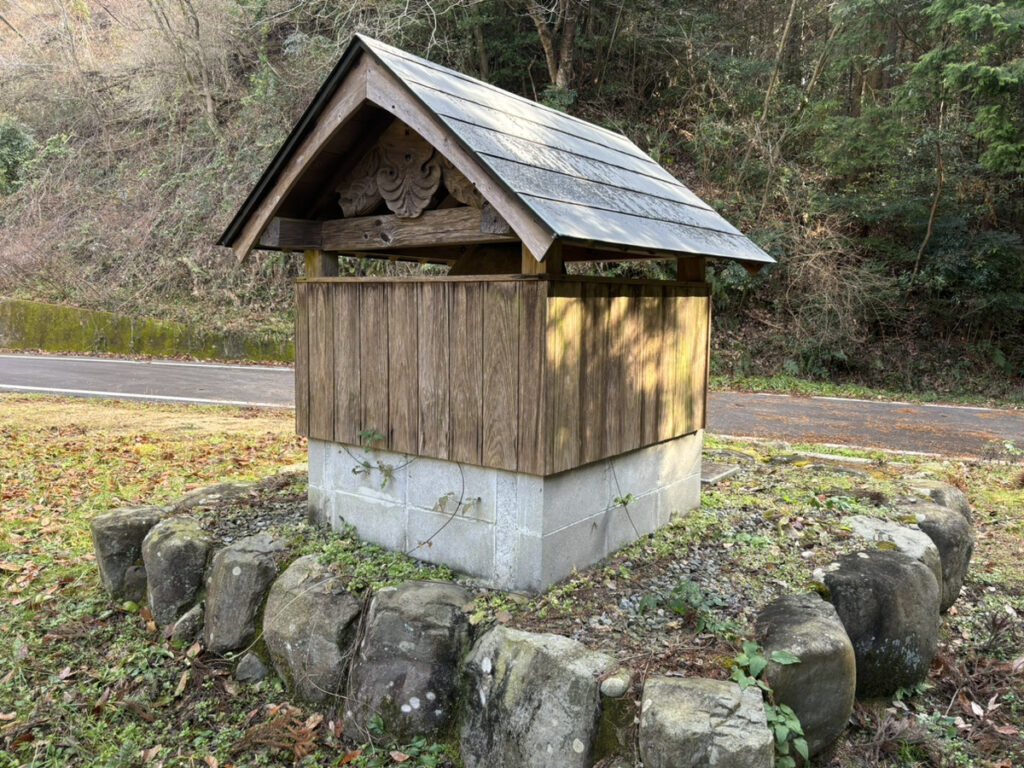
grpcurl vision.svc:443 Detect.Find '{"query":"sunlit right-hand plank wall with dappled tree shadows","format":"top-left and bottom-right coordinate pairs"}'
top-left (544, 279), bottom-right (711, 474)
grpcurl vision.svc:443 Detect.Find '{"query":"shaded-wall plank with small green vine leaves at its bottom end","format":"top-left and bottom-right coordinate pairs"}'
top-left (359, 284), bottom-right (389, 449)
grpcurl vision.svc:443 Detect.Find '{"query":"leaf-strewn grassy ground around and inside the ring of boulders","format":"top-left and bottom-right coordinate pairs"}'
top-left (0, 395), bottom-right (1024, 768)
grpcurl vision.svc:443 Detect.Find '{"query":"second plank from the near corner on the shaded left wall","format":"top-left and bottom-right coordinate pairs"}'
top-left (483, 283), bottom-right (519, 471)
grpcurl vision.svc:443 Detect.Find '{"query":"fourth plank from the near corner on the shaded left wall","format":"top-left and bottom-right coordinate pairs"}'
top-left (417, 283), bottom-right (450, 459)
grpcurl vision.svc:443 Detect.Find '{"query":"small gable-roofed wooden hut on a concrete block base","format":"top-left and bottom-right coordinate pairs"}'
top-left (219, 36), bottom-right (772, 589)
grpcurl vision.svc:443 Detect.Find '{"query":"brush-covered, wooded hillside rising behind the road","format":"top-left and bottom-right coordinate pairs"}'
top-left (0, 0), bottom-right (1024, 397)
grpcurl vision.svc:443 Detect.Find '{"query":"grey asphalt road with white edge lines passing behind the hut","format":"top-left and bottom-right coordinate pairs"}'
top-left (0, 354), bottom-right (1024, 457)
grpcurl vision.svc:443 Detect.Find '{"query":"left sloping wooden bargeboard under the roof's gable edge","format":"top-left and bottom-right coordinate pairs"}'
top-left (231, 56), bottom-right (367, 261)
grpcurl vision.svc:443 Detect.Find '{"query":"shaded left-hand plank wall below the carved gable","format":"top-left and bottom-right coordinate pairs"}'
top-left (296, 279), bottom-right (546, 474)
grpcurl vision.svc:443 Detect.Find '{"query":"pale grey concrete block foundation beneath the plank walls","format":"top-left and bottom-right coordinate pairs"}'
top-left (309, 431), bottom-right (703, 592)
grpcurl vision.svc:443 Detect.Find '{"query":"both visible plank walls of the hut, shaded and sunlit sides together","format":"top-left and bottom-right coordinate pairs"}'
top-left (296, 278), bottom-right (710, 475)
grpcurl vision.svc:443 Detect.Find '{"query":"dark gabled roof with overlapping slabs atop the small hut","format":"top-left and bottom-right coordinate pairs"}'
top-left (218, 35), bottom-right (774, 264)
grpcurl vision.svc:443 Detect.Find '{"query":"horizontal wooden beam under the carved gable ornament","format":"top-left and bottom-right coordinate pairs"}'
top-left (321, 207), bottom-right (516, 253)
